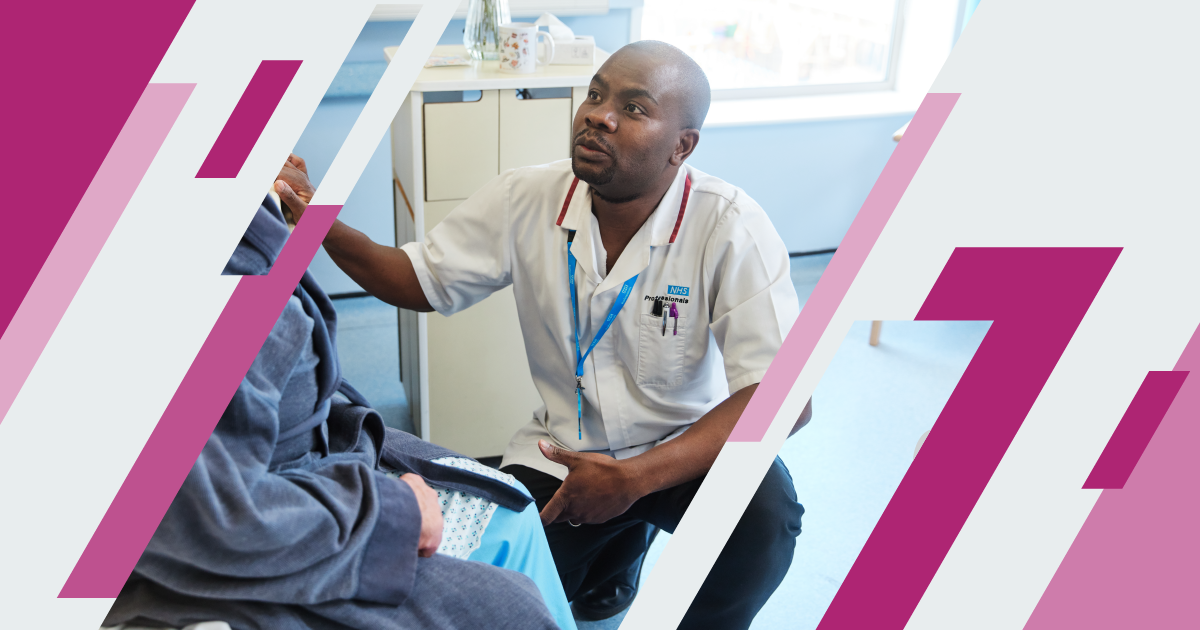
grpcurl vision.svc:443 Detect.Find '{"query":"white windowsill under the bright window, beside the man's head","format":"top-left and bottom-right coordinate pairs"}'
top-left (704, 90), bottom-right (925, 128)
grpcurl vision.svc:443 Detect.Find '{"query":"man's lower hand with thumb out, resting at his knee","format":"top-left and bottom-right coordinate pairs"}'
top-left (538, 440), bottom-right (646, 526)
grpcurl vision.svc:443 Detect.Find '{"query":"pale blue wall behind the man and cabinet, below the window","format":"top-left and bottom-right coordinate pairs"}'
top-left (302, 8), bottom-right (911, 293)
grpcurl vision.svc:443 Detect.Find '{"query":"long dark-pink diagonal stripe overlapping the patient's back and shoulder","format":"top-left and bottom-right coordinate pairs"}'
top-left (59, 205), bottom-right (342, 598)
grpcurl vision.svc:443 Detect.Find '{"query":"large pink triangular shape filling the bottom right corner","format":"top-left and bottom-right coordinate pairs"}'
top-left (1025, 328), bottom-right (1200, 630)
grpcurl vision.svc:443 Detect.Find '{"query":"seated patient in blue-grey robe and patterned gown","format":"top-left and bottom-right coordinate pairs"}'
top-left (106, 158), bottom-right (575, 630)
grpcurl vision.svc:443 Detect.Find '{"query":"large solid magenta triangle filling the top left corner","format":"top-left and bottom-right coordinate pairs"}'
top-left (0, 0), bottom-right (192, 335)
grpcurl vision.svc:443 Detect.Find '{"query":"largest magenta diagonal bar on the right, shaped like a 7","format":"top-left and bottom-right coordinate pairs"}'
top-left (817, 247), bottom-right (1121, 630)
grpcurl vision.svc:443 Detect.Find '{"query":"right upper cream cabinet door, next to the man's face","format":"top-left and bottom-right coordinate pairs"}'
top-left (499, 90), bottom-right (575, 172)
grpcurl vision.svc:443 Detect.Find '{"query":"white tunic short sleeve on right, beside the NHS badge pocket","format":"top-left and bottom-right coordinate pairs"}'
top-left (704, 202), bottom-right (800, 392)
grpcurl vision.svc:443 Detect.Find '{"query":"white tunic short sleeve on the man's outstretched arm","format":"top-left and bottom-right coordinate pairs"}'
top-left (401, 172), bottom-right (512, 316)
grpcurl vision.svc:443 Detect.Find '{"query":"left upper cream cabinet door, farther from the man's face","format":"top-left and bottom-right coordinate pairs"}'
top-left (425, 90), bottom-right (500, 202)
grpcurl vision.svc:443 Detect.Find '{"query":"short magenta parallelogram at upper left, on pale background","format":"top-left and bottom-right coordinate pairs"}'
top-left (196, 60), bottom-right (300, 178)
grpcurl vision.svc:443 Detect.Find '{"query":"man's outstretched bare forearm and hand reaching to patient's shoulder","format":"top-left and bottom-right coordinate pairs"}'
top-left (275, 156), bottom-right (433, 313)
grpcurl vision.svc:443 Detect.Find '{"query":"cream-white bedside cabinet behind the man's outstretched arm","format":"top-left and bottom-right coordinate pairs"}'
top-left (385, 46), bottom-right (608, 457)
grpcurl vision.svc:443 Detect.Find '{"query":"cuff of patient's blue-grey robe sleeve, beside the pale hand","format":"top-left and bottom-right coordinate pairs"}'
top-left (355, 473), bottom-right (421, 606)
